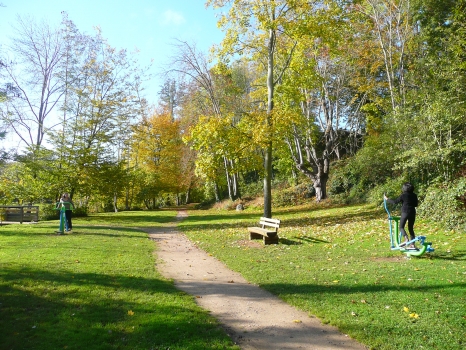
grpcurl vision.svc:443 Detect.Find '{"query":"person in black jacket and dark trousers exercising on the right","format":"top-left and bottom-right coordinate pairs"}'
top-left (384, 182), bottom-right (418, 249)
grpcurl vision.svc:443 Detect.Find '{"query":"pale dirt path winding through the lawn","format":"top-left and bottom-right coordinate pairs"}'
top-left (144, 211), bottom-right (365, 350)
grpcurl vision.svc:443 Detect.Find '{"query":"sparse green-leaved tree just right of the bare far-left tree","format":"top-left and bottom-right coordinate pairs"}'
top-left (50, 30), bottom-right (145, 208)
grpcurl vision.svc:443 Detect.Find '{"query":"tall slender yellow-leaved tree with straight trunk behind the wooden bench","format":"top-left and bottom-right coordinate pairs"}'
top-left (207, 0), bottom-right (308, 218)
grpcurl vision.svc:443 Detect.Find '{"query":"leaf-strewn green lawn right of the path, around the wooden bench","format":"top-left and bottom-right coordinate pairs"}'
top-left (180, 204), bottom-right (466, 349)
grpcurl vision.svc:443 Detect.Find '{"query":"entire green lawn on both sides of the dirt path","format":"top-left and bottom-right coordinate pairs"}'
top-left (0, 204), bottom-right (466, 349)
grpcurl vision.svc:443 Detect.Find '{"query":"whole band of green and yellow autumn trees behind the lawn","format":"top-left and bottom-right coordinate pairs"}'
top-left (0, 0), bottom-right (466, 230)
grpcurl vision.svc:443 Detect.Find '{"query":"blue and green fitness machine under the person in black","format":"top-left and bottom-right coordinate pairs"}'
top-left (383, 199), bottom-right (434, 257)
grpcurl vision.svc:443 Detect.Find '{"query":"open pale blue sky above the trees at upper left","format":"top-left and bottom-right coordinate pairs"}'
top-left (0, 0), bottom-right (223, 103)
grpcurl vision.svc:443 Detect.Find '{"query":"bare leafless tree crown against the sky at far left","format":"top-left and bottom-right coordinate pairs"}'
top-left (0, 17), bottom-right (65, 149)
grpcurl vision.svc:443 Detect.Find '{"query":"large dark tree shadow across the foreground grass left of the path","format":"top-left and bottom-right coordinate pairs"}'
top-left (0, 268), bottom-right (237, 350)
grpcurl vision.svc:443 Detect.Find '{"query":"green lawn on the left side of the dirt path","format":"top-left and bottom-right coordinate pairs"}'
top-left (0, 211), bottom-right (237, 350)
